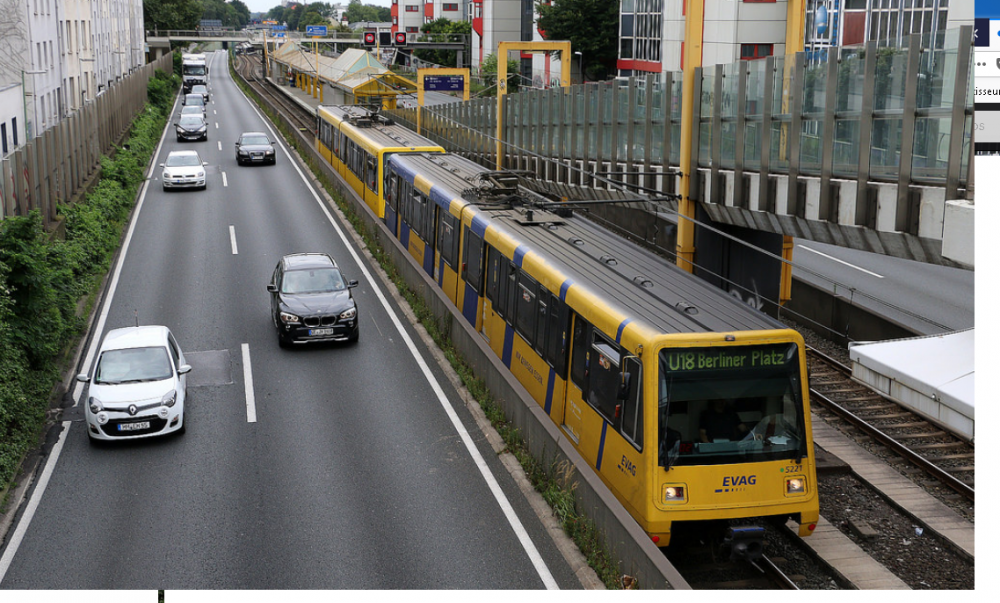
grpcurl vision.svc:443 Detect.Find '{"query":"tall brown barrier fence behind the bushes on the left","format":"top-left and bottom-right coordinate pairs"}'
top-left (0, 54), bottom-right (174, 226)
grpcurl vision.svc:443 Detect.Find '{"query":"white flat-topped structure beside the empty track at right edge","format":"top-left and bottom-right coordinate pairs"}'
top-left (850, 329), bottom-right (976, 441)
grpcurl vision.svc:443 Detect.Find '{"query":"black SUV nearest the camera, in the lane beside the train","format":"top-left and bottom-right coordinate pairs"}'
top-left (267, 253), bottom-right (359, 347)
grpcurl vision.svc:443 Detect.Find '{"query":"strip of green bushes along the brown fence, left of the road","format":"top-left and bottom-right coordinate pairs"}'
top-left (0, 96), bottom-right (177, 489)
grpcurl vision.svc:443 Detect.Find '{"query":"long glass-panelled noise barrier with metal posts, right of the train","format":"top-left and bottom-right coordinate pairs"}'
top-left (392, 26), bottom-right (974, 214)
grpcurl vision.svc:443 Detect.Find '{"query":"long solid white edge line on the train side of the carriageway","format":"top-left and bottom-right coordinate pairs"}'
top-left (244, 96), bottom-right (559, 590)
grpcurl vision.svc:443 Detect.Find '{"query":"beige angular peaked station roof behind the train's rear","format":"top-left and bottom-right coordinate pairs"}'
top-left (272, 40), bottom-right (417, 97)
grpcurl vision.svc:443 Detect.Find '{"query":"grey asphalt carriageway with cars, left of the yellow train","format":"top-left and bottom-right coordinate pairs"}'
top-left (0, 54), bottom-right (579, 590)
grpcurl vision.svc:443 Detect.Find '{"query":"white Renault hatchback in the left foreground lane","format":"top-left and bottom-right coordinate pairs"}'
top-left (76, 326), bottom-right (191, 441)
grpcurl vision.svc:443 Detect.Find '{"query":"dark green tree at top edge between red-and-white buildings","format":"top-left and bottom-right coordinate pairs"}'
top-left (535, 0), bottom-right (618, 78)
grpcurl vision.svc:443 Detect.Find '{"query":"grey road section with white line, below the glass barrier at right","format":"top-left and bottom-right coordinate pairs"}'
top-left (792, 239), bottom-right (975, 335)
